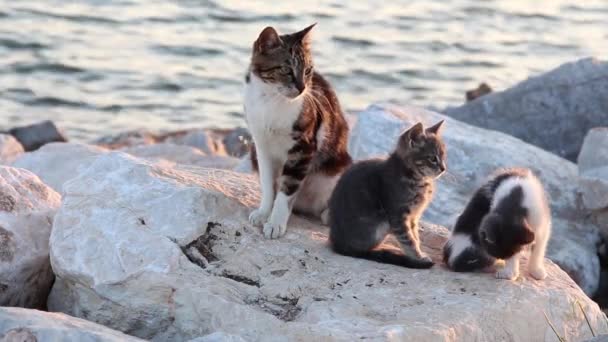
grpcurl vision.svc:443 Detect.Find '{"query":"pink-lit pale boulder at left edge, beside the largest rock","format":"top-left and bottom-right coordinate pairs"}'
top-left (0, 166), bottom-right (61, 308)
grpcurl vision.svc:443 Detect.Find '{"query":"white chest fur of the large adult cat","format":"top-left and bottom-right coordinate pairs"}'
top-left (244, 74), bottom-right (303, 156)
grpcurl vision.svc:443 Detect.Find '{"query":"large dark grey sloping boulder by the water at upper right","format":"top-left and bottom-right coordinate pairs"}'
top-left (446, 58), bottom-right (608, 161)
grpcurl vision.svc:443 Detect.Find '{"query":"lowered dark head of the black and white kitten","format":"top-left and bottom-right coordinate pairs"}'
top-left (479, 213), bottom-right (534, 259)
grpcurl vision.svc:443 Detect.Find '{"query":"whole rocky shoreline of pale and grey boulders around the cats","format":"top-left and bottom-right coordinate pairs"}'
top-left (0, 59), bottom-right (608, 341)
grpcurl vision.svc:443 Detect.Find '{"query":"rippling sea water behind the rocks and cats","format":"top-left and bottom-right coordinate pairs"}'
top-left (0, 0), bottom-right (608, 139)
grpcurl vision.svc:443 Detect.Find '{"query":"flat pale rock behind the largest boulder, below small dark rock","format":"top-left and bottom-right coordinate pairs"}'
top-left (12, 142), bottom-right (106, 193)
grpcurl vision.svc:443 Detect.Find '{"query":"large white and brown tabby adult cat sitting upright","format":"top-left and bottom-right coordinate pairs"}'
top-left (245, 25), bottom-right (351, 238)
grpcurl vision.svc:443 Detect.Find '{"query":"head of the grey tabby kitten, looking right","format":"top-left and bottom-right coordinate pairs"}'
top-left (395, 120), bottom-right (447, 178)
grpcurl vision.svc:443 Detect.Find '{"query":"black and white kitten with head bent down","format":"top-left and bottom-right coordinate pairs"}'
top-left (443, 168), bottom-right (551, 280)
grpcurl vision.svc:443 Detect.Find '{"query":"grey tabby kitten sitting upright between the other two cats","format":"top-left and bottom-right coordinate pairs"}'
top-left (329, 121), bottom-right (446, 268)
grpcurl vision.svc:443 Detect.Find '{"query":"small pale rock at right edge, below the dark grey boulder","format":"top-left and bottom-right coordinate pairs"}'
top-left (578, 129), bottom-right (608, 211)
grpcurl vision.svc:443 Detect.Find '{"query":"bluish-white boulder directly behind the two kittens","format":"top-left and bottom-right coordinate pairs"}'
top-left (349, 105), bottom-right (600, 295)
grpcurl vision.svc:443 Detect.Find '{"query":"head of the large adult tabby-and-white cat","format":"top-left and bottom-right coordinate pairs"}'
top-left (251, 24), bottom-right (316, 98)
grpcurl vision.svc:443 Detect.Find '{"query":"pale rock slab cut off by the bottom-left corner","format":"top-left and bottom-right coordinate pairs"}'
top-left (0, 307), bottom-right (143, 342)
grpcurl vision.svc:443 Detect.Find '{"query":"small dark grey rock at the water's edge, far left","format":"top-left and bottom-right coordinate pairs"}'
top-left (8, 120), bottom-right (68, 151)
